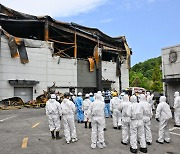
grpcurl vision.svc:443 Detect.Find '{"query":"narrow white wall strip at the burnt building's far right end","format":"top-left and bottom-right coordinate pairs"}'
top-left (121, 60), bottom-right (129, 89)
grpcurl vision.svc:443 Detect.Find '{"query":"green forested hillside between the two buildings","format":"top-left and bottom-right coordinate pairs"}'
top-left (129, 56), bottom-right (163, 92)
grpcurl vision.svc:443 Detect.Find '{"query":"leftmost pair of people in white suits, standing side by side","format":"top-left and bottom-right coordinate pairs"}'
top-left (46, 93), bottom-right (78, 144)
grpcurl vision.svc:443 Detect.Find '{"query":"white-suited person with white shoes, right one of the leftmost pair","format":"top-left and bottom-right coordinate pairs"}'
top-left (61, 92), bottom-right (78, 144)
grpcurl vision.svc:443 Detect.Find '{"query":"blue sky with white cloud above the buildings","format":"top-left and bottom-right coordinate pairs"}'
top-left (0, 0), bottom-right (180, 66)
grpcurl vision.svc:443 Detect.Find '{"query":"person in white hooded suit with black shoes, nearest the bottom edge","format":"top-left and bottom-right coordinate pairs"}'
top-left (127, 95), bottom-right (147, 152)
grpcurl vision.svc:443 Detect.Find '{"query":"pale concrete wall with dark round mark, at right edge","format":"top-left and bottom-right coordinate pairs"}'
top-left (161, 45), bottom-right (180, 107)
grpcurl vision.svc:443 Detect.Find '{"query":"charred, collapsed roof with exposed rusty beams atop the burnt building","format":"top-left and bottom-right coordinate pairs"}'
top-left (0, 4), bottom-right (131, 61)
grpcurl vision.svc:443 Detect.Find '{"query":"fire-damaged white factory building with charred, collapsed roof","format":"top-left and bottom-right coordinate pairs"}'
top-left (0, 4), bottom-right (132, 102)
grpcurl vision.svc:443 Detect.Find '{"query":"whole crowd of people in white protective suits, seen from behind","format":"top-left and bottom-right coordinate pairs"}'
top-left (46, 91), bottom-right (180, 153)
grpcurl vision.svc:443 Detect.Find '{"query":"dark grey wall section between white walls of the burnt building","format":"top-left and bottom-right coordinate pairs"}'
top-left (77, 60), bottom-right (96, 88)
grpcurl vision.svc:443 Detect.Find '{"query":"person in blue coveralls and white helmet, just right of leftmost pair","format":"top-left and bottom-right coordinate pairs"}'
top-left (75, 92), bottom-right (84, 123)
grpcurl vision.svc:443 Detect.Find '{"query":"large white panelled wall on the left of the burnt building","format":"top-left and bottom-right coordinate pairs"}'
top-left (0, 37), bottom-right (77, 100)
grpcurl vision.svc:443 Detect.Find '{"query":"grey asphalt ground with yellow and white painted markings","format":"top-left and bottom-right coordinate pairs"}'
top-left (0, 108), bottom-right (180, 154)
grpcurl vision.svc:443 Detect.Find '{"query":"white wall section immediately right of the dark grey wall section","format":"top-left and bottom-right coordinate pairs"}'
top-left (102, 61), bottom-right (119, 91)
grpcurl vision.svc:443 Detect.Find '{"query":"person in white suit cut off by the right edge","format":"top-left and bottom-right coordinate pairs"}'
top-left (174, 91), bottom-right (180, 127)
